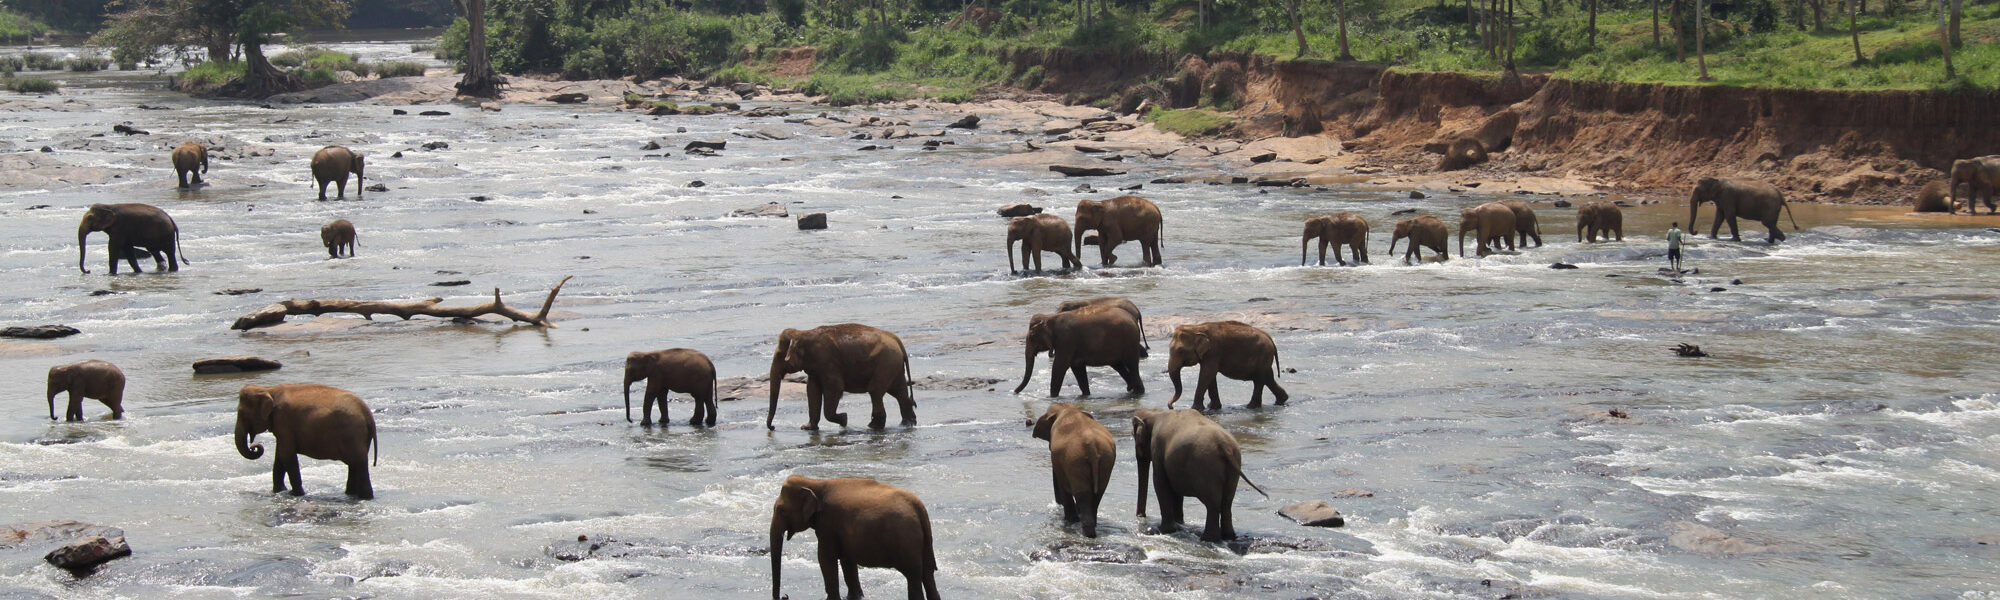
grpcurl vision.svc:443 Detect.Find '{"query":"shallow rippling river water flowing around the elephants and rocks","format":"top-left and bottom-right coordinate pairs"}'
top-left (0, 42), bottom-right (2000, 598)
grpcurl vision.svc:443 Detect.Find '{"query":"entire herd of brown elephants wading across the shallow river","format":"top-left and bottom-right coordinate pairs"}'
top-left (48, 142), bottom-right (2000, 598)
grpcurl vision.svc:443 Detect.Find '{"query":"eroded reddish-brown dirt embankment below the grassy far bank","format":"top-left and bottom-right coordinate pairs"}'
top-left (1012, 52), bottom-right (2000, 204)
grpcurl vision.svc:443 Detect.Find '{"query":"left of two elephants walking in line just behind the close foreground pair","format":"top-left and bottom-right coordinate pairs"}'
top-left (1014, 304), bottom-right (1146, 396)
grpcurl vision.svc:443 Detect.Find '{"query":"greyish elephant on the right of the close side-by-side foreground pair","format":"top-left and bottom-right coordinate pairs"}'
top-left (1132, 408), bottom-right (1270, 542)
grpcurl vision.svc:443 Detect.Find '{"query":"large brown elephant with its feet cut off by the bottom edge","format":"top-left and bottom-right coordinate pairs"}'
top-left (770, 474), bottom-right (938, 600)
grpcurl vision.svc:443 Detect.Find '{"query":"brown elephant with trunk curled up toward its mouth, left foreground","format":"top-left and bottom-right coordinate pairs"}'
top-left (236, 384), bottom-right (382, 500)
